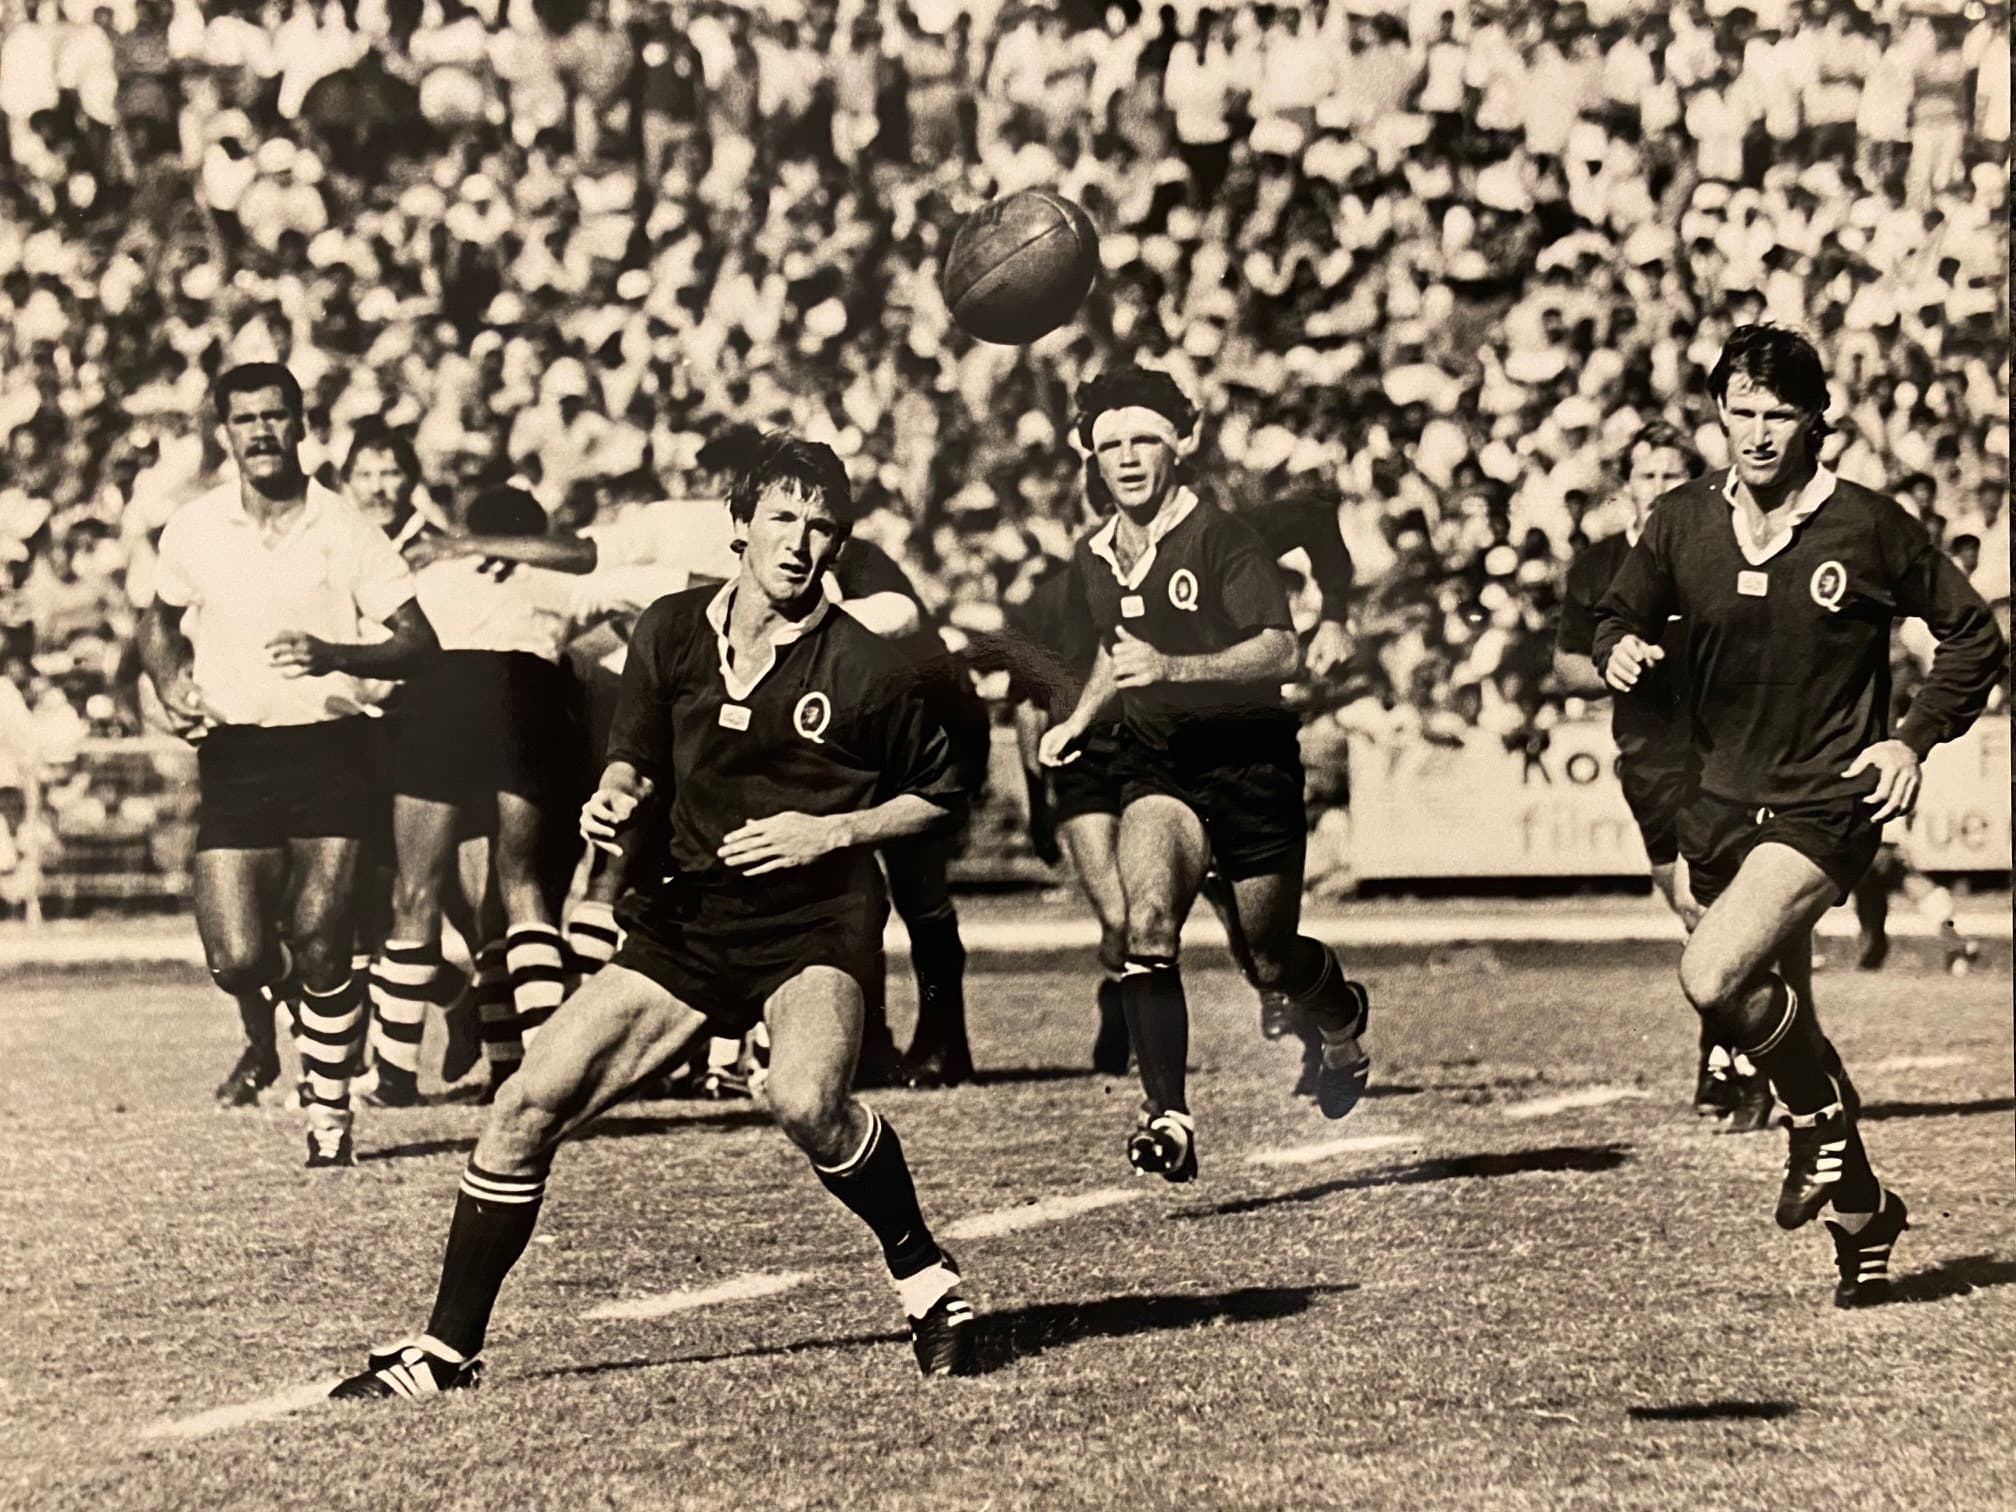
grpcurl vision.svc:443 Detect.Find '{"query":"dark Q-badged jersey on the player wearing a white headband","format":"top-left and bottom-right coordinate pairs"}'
top-left (1073, 488), bottom-right (1294, 756)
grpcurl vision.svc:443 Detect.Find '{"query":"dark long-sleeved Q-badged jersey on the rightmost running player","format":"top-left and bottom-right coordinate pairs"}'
top-left (1595, 470), bottom-right (2004, 804)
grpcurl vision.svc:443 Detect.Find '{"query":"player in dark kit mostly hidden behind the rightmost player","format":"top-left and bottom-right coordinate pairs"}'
top-left (1554, 421), bottom-right (1772, 1133)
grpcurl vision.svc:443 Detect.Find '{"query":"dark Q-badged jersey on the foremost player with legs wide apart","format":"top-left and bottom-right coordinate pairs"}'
top-left (609, 583), bottom-right (966, 899)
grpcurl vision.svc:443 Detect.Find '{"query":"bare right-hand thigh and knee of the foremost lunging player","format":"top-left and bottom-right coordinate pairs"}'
top-left (764, 966), bottom-right (869, 1165)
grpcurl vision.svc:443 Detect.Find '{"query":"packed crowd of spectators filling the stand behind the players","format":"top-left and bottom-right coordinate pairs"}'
top-left (0, 0), bottom-right (2010, 887)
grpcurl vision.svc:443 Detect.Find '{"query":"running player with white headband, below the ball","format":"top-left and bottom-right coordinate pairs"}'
top-left (1040, 367), bottom-right (1371, 1181)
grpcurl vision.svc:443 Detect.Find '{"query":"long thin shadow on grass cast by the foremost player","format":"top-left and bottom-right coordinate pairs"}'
top-left (538, 1282), bottom-right (1359, 1379)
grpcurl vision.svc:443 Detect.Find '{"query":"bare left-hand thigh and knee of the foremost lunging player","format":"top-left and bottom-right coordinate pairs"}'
top-left (476, 966), bottom-right (708, 1175)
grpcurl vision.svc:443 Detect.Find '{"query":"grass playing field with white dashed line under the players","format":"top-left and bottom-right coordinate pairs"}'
top-left (0, 946), bottom-right (2016, 1512)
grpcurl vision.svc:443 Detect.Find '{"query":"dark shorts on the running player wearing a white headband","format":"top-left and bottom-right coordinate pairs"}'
top-left (1113, 720), bottom-right (1308, 881)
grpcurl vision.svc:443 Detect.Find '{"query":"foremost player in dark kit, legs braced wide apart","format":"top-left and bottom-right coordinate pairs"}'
top-left (333, 437), bottom-right (974, 1397)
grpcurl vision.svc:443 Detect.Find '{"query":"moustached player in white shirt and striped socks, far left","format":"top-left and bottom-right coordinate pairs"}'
top-left (137, 363), bottom-right (435, 1165)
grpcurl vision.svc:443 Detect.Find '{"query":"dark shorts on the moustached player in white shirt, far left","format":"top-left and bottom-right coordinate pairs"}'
top-left (196, 716), bottom-right (385, 851)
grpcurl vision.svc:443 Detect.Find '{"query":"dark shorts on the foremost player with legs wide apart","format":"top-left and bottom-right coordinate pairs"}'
top-left (615, 863), bottom-right (889, 1036)
